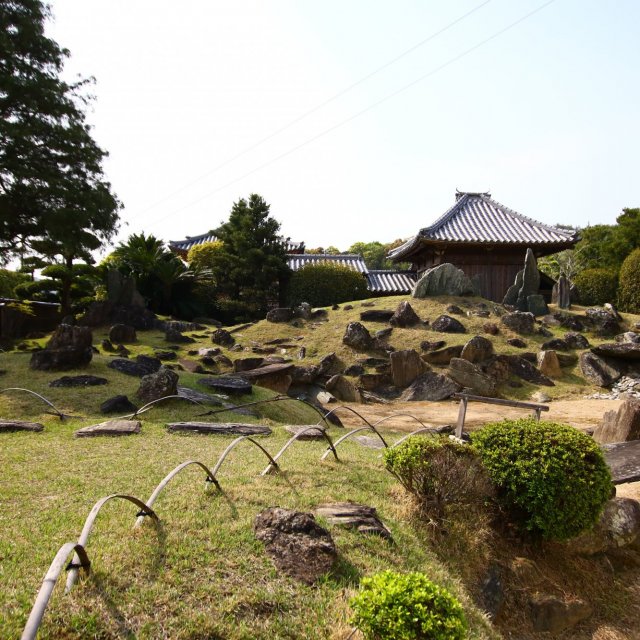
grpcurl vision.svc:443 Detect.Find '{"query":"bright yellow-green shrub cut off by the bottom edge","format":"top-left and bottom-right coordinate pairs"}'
top-left (350, 571), bottom-right (467, 640)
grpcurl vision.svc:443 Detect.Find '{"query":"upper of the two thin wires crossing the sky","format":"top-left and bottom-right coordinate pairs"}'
top-left (135, 0), bottom-right (491, 214)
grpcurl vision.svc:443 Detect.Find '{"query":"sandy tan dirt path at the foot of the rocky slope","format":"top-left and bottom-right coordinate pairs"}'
top-left (338, 400), bottom-right (621, 431)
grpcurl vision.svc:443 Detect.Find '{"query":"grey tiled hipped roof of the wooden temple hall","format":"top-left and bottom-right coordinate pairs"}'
top-left (389, 193), bottom-right (576, 259)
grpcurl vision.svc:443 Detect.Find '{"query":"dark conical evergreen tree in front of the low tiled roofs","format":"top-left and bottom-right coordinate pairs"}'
top-left (212, 194), bottom-right (290, 313)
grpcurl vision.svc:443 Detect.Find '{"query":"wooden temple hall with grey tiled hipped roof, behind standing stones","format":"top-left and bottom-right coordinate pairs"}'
top-left (389, 191), bottom-right (578, 302)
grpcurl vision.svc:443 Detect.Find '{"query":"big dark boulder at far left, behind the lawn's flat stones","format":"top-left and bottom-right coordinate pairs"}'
top-left (29, 324), bottom-right (93, 371)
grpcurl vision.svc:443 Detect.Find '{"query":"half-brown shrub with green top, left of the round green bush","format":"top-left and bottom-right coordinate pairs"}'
top-left (384, 436), bottom-right (494, 518)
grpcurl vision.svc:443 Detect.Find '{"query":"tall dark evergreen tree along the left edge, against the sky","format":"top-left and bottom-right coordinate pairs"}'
top-left (0, 0), bottom-right (120, 271)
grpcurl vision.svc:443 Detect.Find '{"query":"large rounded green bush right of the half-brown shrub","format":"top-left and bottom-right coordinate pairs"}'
top-left (472, 418), bottom-right (612, 540)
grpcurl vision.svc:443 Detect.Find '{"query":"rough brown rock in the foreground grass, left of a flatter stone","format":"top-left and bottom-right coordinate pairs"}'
top-left (253, 507), bottom-right (338, 584)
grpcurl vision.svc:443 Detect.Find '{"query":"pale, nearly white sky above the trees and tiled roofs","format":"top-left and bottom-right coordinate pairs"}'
top-left (47, 0), bottom-right (640, 255)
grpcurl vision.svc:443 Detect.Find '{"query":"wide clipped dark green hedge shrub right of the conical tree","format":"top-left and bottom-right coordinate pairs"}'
top-left (287, 263), bottom-right (369, 307)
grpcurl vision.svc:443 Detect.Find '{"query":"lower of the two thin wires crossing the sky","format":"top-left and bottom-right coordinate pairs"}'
top-left (150, 0), bottom-right (555, 230)
